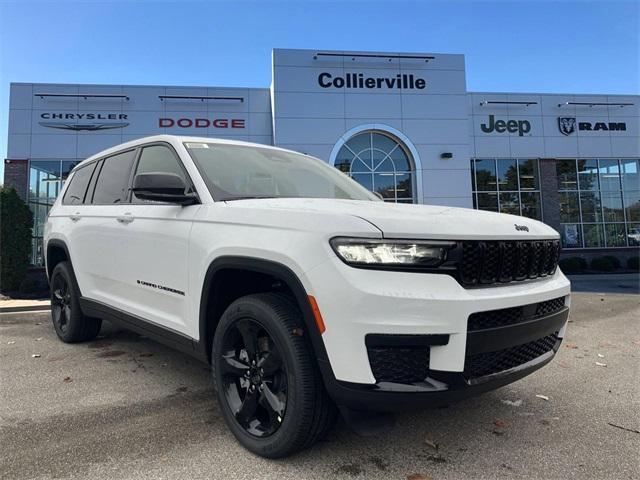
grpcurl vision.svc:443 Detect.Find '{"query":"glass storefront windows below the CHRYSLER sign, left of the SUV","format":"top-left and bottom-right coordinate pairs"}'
top-left (28, 160), bottom-right (80, 266)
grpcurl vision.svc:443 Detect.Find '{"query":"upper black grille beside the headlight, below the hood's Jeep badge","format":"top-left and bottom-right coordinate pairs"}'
top-left (459, 240), bottom-right (560, 286)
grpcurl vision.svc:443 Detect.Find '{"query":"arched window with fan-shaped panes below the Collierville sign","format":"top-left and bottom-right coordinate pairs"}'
top-left (334, 130), bottom-right (415, 203)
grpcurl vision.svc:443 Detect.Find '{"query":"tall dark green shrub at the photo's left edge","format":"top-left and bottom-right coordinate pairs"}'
top-left (0, 187), bottom-right (33, 292)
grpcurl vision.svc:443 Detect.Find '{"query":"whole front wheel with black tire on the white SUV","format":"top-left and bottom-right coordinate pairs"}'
top-left (211, 293), bottom-right (337, 458)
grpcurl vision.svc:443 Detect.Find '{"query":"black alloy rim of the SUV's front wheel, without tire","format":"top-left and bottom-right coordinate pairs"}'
top-left (220, 318), bottom-right (287, 437)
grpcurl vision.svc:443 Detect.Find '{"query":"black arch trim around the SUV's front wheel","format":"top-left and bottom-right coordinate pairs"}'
top-left (196, 256), bottom-right (335, 370)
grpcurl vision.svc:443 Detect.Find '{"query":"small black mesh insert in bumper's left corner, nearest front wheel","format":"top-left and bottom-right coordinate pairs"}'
top-left (367, 347), bottom-right (429, 383)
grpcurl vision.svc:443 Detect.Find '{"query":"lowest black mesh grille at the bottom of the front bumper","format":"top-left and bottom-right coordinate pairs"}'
top-left (464, 332), bottom-right (558, 379)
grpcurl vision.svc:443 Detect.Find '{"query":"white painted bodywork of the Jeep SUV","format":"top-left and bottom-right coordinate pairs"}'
top-left (45, 136), bottom-right (569, 384)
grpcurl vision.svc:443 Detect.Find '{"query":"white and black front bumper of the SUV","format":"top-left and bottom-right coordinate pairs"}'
top-left (308, 256), bottom-right (569, 410)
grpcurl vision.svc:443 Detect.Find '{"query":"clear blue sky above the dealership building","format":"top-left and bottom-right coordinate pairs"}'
top-left (0, 0), bottom-right (640, 182)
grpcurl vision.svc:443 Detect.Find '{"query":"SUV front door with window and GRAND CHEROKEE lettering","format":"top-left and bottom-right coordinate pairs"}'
top-left (109, 142), bottom-right (200, 336)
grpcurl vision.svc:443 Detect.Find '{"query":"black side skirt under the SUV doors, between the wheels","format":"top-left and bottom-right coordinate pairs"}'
top-left (80, 297), bottom-right (208, 363)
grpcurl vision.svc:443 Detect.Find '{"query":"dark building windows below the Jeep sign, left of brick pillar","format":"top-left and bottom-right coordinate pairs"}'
top-left (471, 158), bottom-right (542, 220)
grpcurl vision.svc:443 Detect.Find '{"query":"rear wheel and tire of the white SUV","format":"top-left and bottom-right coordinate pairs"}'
top-left (50, 261), bottom-right (102, 343)
